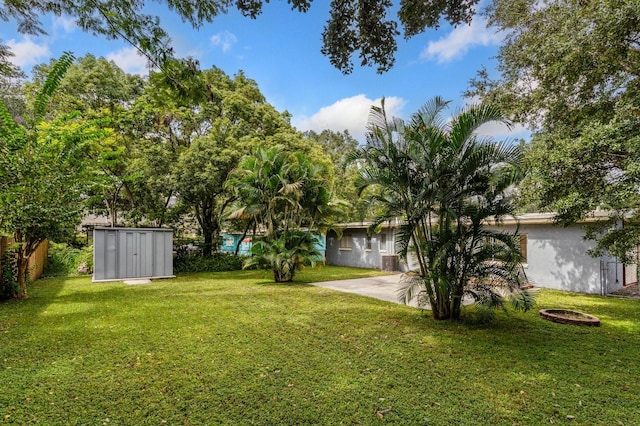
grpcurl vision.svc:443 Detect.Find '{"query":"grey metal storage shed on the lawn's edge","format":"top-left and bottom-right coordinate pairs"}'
top-left (93, 227), bottom-right (174, 282)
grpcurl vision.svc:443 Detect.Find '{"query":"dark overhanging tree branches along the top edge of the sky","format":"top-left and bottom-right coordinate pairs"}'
top-left (0, 0), bottom-right (478, 73)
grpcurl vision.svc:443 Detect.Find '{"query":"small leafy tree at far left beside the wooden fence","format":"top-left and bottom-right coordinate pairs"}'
top-left (0, 53), bottom-right (104, 298)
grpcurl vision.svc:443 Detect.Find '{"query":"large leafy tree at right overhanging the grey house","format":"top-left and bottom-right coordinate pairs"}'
top-left (468, 0), bottom-right (640, 259)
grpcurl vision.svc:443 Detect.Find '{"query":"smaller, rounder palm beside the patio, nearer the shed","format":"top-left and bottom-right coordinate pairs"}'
top-left (229, 146), bottom-right (332, 282)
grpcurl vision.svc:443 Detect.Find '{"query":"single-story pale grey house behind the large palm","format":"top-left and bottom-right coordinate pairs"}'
top-left (326, 213), bottom-right (638, 294)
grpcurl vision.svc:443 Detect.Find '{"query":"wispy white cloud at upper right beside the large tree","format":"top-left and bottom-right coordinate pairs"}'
top-left (420, 18), bottom-right (503, 63)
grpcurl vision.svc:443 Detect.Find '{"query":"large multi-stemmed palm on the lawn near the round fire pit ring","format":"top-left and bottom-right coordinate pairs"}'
top-left (353, 97), bottom-right (533, 319)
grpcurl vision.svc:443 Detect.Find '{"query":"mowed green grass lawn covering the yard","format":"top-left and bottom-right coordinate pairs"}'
top-left (0, 267), bottom-right (640, 425)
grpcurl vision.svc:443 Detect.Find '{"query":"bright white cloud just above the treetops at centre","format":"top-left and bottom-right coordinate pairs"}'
top-left (293, 94), bottom-right (406, 142)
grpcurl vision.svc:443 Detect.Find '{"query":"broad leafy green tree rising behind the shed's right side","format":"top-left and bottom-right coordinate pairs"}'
top-left (128, 63), bottom-right (321, 256)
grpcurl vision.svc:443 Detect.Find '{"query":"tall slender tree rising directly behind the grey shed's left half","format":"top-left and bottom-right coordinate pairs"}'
top-left (32, 54), bottom-right (144, 226)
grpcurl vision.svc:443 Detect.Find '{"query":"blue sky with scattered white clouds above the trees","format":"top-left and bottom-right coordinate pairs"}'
top-left (0, 1), bottom-right (523, 140)
